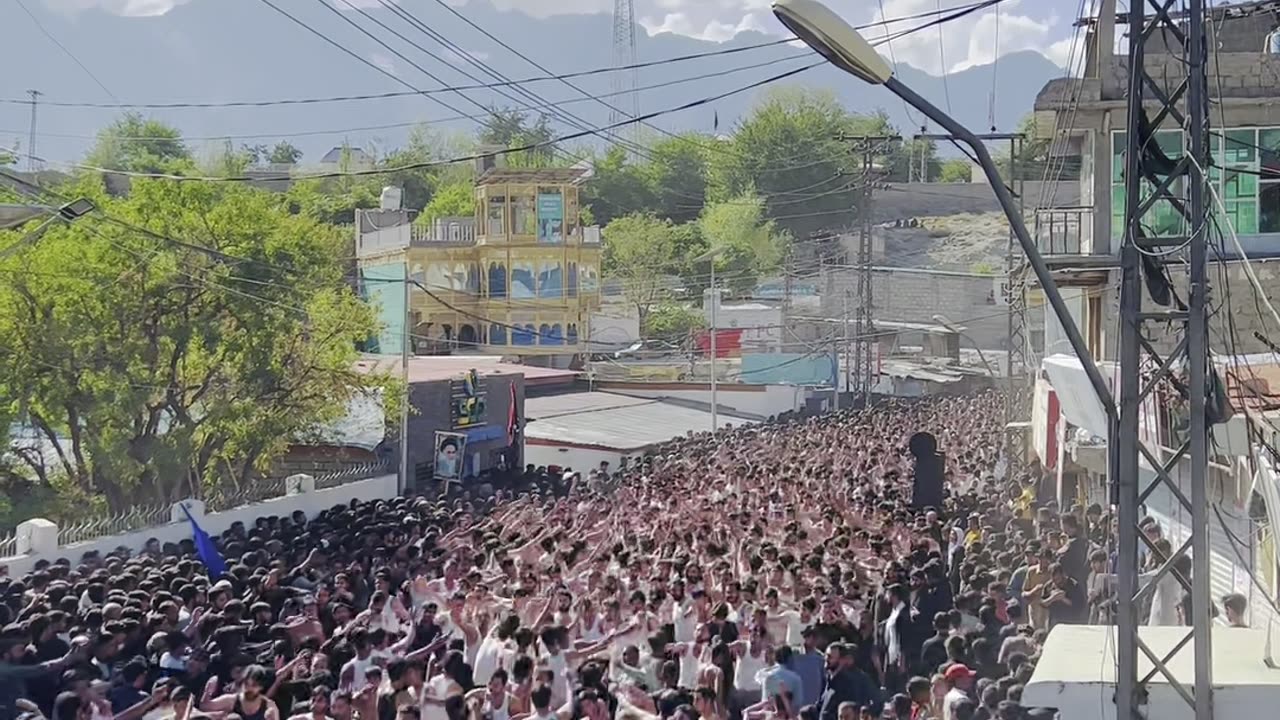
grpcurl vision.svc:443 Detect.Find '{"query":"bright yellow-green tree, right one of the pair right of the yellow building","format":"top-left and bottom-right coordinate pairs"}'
top-left (698, 195), bottom-right (791, 293)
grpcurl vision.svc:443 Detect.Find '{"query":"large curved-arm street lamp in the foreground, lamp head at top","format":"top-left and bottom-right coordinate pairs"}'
top-left (773, 0), bottom-right (1116, 418)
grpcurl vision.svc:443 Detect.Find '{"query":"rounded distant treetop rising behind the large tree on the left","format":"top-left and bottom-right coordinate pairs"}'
top-left (84, 113), bottom-right (191, 173)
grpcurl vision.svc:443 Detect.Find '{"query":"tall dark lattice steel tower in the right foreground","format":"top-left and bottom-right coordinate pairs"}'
top-left (1121, 0), bottom-right (1213, 720)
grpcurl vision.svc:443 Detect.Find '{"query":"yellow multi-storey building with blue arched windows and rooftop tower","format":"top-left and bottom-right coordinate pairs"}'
top-left (356, 168), bottom-right (600, 356)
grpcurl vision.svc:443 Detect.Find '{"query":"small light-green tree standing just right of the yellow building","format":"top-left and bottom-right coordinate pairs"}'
top-left (603, 213), bottom-right (677, 327)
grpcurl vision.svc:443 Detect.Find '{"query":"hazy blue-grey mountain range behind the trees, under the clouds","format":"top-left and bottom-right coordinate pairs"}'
top-left (0, 0), bottom-right (1064, 163)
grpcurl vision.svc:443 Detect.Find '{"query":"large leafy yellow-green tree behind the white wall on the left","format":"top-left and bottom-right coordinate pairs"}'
top-left (0, 174), bottom-right (394, 510)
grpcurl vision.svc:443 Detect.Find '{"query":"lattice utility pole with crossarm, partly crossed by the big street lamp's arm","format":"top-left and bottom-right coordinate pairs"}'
top-left (915, 132), bottom-right (1028, 435)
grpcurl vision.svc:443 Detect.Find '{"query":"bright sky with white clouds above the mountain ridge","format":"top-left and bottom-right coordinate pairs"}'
top-left (38, 0), bottom-right (1094, 74)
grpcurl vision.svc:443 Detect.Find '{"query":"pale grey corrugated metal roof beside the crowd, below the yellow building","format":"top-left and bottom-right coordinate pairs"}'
top-left (525, 392), bottom-right (750, 451)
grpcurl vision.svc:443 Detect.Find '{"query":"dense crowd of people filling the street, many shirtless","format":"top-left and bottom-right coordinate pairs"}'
top-left (0, 393), bottom-right (1230, 720)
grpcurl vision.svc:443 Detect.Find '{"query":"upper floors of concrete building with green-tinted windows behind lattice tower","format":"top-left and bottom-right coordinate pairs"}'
top-left (1036, 0), bottom-right (1280, 359)
